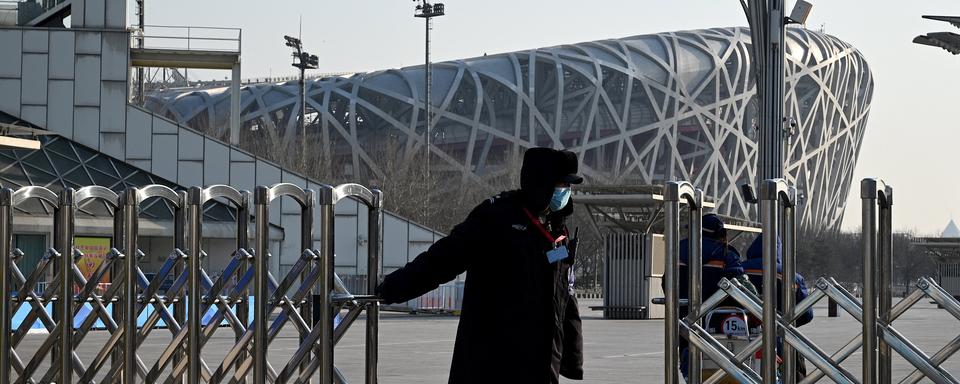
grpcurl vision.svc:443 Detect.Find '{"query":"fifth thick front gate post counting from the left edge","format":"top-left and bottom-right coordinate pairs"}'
top-left (253, 185), bottom-right (271, 384)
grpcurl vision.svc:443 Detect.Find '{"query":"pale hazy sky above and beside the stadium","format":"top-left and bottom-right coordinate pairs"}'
top-left (139, 0), bottom-right (960, 234)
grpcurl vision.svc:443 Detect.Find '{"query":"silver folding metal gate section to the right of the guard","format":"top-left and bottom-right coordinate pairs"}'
top-left (664, 179), bottom-right (960, 384)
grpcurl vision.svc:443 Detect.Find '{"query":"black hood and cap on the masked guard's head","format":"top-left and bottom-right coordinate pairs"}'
top-left (520, 148), bottom-right (583, 212)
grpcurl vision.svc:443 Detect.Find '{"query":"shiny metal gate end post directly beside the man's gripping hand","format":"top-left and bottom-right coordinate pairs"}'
top-left (365, 189), bottom-right (383, 384)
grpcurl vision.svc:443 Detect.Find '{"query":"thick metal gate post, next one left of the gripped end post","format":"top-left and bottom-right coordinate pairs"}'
top-left (316, 186), bottom-right (334, 384)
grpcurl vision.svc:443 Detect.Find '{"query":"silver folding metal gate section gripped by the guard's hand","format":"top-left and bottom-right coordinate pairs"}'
top-left (0, 183), bottom-right (383, 384)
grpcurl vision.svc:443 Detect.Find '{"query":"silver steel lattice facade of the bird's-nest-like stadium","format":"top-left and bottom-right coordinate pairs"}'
top-left (147, 28), bottom-right (874, 229)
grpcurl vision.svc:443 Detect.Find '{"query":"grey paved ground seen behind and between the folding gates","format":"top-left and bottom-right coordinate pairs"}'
top-left (7, 300), bottom-right (960, 384)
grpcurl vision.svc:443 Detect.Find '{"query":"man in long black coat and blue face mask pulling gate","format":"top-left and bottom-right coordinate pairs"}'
top-left (378, 148), bottom-right (583, 384)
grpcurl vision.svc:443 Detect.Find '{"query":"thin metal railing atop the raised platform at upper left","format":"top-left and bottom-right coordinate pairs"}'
top-left (130, 25), bottom-right (243, 53)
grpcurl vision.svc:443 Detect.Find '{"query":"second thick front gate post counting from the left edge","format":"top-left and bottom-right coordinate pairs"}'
top-left (57, 188), bottom-right (76, 384)
